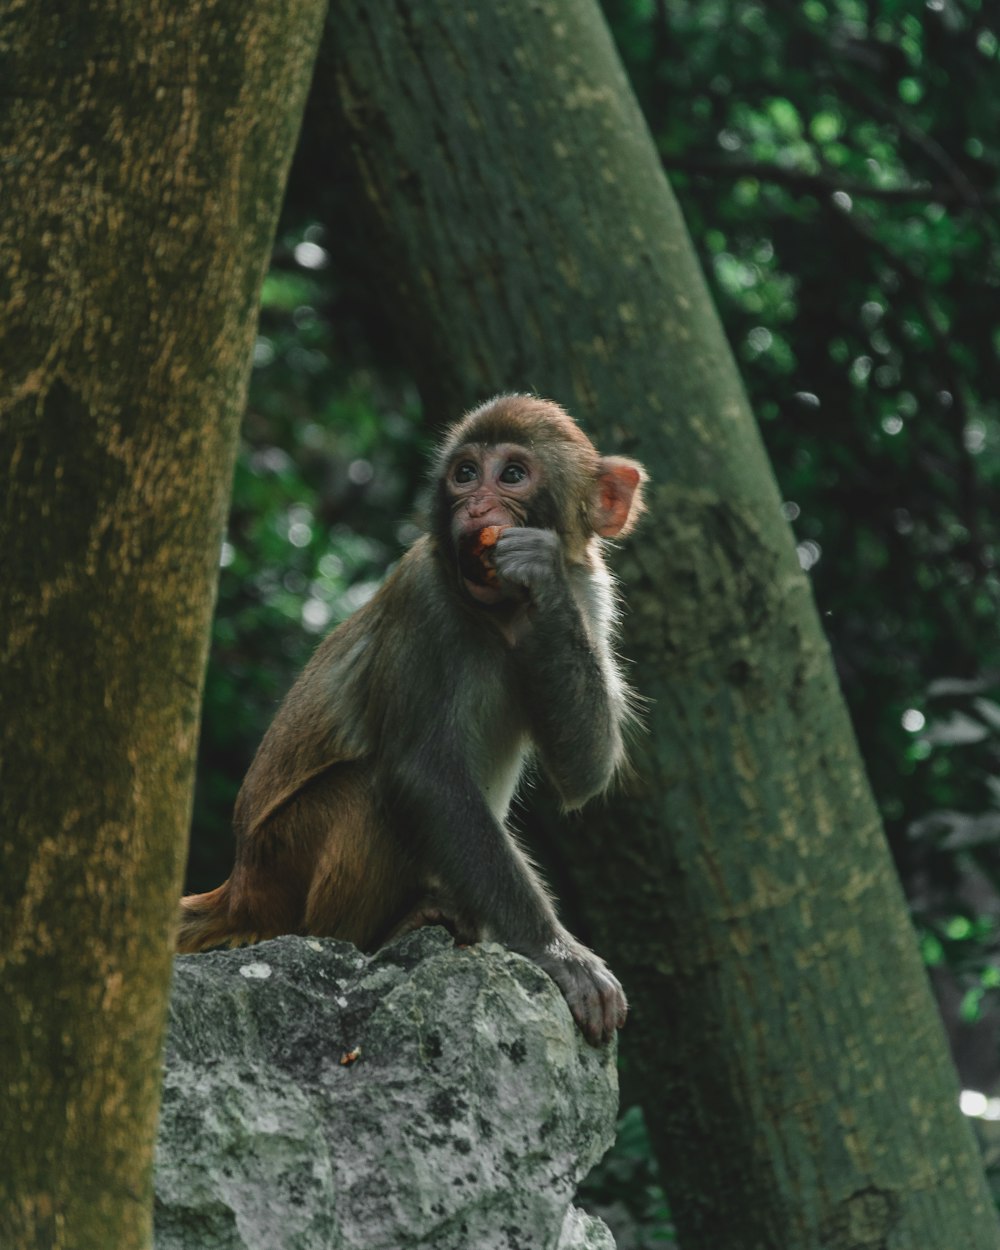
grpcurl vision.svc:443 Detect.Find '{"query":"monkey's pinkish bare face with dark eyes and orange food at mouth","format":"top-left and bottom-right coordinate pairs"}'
top-left (443, 443), bottom-right (543, 604)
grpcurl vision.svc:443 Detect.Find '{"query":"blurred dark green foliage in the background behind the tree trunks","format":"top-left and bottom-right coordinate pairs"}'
top-left (189, 0), bottom-right (1000, 1250)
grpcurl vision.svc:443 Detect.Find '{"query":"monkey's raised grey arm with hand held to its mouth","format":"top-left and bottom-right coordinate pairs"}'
top-left (496, 528), bottom-right (629, 809)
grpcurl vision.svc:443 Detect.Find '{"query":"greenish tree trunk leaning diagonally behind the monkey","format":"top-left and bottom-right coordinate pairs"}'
top-left (316, 0), bottom-right (998, 1250)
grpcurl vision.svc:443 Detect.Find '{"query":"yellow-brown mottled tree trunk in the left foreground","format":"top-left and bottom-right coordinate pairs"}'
top-left (0, 0), bottom-right (324, 1250)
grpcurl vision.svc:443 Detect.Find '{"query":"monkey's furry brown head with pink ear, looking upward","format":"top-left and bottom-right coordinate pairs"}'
top-left (433, 395), bottom-right (646, 605)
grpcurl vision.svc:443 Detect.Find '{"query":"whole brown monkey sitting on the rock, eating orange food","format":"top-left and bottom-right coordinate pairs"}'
top-left (178, 395), bottom-right (645, 1044)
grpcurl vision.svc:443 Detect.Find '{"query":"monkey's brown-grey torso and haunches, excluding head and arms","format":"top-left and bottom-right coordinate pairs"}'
top-left (179, 538), bottom-right (529, 950)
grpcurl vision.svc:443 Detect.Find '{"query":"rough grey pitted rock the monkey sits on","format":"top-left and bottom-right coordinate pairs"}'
top-left (155, 929), bottom-right (618, 1250)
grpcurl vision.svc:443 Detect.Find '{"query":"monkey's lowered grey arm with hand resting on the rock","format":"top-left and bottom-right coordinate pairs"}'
top-left (380, 734), bottom-right (628, 1045)
